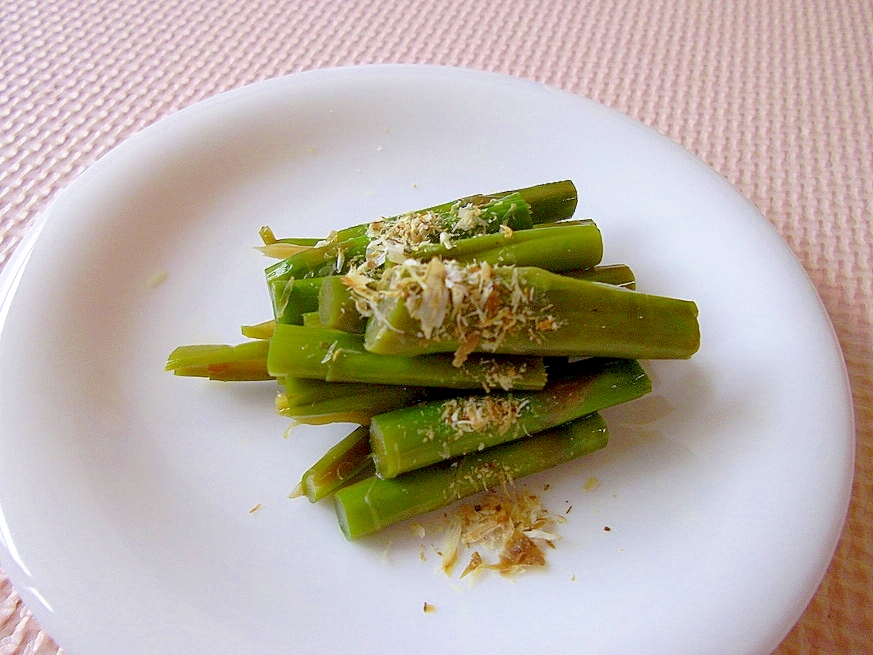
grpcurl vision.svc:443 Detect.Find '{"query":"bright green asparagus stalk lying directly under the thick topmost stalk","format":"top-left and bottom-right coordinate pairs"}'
top-left (267, 324), bottom-right (546, 390)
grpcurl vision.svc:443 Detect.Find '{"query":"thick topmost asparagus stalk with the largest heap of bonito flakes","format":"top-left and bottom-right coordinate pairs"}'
top-left (364, 259), bottom-right (700, 362)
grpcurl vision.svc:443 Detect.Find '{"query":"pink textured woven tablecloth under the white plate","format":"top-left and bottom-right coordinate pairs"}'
top-left (0, 0), bottom-right (873, 655)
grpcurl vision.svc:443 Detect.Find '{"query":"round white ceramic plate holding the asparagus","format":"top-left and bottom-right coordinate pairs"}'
top-left (0, 66), bottom-right (854, 655)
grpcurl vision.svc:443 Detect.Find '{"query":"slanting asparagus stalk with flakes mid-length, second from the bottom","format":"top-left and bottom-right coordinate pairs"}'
top-left (370, 359), bottom-right (652, 478)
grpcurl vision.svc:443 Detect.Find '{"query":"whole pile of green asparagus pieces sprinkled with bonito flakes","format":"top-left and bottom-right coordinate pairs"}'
top-left (167, 181), bottom-right (700, 539)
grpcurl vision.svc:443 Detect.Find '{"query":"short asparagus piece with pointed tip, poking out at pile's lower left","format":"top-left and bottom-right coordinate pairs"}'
top-left (291, 427), bottom-right (374, 503)
